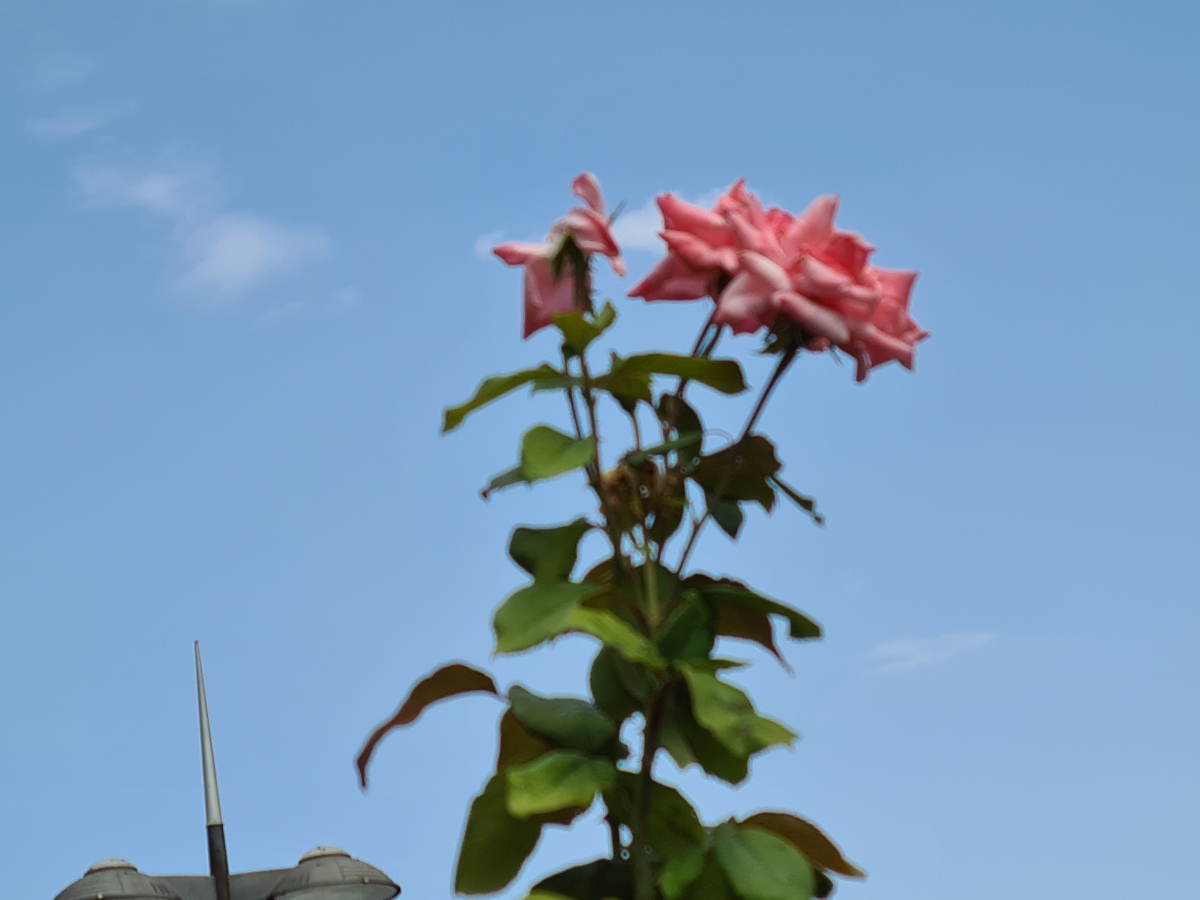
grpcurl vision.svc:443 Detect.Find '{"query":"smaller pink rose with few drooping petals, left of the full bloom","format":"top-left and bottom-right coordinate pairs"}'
top-left (492, 172), bottom-right (625, 337)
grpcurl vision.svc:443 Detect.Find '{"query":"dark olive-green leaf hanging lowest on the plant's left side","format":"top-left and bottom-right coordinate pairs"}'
top-left (454, 774), bottom-right (542, 894)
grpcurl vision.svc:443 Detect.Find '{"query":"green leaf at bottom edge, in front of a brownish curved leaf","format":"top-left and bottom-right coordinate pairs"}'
top-left (713, 823), bottom-right (815, 900)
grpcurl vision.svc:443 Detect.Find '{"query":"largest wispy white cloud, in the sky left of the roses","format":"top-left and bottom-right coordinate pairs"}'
top-left (73, 160), bottom-right (332, 304)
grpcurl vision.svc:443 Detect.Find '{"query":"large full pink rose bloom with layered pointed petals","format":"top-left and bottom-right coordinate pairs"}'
top-left (629, 181), bottom-right (929, 382)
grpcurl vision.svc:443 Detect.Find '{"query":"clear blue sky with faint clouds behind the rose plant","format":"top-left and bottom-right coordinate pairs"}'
top-left (0, 0), bottom-right (1200, 900)
